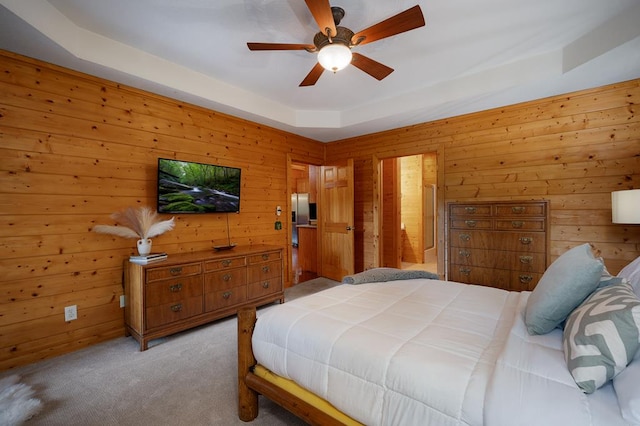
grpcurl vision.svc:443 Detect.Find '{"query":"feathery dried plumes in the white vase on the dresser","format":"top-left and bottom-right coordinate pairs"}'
top-left (93, 207), bottom-right (175, 240)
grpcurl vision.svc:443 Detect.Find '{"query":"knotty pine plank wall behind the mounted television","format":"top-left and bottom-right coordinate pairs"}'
top-left (0, 51), bottom-right (324, 371)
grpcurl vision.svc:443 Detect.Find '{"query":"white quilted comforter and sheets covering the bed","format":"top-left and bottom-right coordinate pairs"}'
top-left (252, 279), bottom-right (624, 426)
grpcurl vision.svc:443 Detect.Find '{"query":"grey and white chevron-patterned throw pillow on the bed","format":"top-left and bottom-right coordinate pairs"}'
top-left (563, 283), bottom-right (640, 393)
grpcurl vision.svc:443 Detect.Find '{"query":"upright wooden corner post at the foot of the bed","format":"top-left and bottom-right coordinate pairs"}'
top-left (238, 307), bottom-right (258, 422)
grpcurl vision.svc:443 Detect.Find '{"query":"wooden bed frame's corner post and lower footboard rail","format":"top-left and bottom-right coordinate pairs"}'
top-left (238, 307), bottom-right (352, 425)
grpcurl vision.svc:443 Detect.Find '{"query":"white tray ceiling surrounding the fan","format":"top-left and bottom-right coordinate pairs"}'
top-left (0, 0), bottom-right (640, 142)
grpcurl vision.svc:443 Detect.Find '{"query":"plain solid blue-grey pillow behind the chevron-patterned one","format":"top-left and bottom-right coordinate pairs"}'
top-left (525, 244), bottom-right (604, 334)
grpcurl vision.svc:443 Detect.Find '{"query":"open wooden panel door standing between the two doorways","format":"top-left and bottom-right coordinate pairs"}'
top-left (318, 159), bottom-right (355, 281)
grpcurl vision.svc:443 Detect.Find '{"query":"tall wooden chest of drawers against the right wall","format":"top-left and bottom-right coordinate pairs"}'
top-left (447, 201), bottom-right (549, 291)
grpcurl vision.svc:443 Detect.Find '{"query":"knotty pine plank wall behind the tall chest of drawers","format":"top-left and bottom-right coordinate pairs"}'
top-left (326, 80), bottom-right (640, 273)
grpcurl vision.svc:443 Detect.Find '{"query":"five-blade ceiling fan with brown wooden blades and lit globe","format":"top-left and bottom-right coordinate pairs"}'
top-left (247, 0), bottom-right (424, 86)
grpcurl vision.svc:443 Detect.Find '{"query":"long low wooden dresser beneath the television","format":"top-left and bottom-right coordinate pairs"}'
top-left (124, 245), bottom-right (284, 351)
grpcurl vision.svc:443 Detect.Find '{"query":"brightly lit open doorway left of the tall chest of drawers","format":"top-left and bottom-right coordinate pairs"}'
top-left (380, 153), bottom-right (438, 272)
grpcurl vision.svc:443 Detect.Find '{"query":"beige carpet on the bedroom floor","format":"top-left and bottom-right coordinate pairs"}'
top-left (0, 278), bottom-right (338, 426)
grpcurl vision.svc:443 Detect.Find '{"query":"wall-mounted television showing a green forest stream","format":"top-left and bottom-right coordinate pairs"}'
top-left (158, 158), bottom-right (241, 214)
